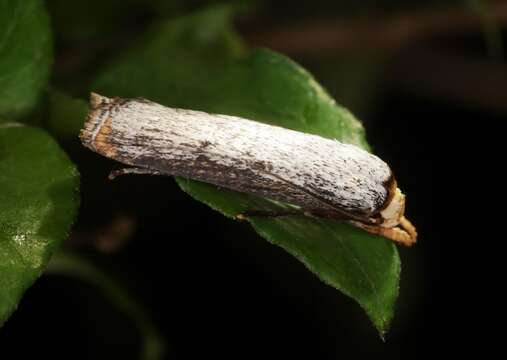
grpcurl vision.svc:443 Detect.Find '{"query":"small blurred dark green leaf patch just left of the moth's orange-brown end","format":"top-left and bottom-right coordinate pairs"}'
top-left (47, 90), bottom-right (88, 140)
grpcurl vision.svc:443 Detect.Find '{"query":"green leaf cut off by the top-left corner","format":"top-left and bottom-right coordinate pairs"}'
top-left (0, 0), bottom-right (52, 118)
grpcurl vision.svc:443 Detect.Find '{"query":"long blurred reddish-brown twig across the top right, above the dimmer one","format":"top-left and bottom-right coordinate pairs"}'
top-left (245, 1), bottom-right (507, 55)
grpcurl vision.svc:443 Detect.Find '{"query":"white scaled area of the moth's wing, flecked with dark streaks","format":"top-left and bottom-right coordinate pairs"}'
top-left (107, 98), bottom-right (391, 213)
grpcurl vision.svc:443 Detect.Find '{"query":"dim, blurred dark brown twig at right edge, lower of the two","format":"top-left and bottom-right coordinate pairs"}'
top-left (388, 48), bottom-right (507, 114)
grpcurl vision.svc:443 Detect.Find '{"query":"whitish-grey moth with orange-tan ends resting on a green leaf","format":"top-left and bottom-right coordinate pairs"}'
top-left (80, 93), bottom-right (417, 246)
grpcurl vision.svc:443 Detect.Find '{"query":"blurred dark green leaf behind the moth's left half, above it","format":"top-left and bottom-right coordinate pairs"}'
top-left (91, 7), bottom-right (248, 107)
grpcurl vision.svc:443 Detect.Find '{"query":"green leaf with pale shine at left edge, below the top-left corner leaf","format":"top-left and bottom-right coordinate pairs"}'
top-left (0, 124), bottom-right (79, 326)
